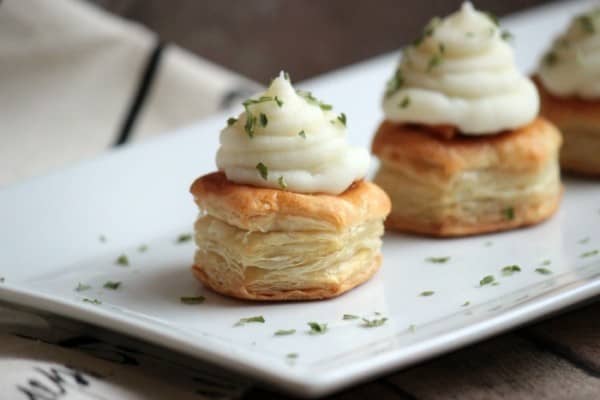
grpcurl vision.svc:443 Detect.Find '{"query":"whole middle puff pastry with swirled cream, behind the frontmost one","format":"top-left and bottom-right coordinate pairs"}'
top-left (372, 2), bottom-right (562, 236)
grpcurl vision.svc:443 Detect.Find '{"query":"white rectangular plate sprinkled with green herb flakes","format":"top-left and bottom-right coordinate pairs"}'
top-left (0, 2), bottom-right (600, 396)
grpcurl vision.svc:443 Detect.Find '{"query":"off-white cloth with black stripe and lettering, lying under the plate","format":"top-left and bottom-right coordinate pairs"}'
top-left (0, 0), bottom-right (258, 400)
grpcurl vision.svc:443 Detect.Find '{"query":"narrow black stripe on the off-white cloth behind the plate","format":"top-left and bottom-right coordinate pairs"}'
top-left (113, 40), bottom-right (165, 146)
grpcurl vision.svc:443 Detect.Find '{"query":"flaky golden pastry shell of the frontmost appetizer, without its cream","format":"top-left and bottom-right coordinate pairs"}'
top-left (191, 172), bottom-right (390, 300)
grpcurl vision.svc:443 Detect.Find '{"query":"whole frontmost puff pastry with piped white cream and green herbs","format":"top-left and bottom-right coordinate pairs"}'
top-left (190, 73), bottom-right (390, 300)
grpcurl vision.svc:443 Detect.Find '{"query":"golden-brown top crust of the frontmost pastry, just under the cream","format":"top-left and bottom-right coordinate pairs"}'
top-left (190, 172), bottom-right (391, 232)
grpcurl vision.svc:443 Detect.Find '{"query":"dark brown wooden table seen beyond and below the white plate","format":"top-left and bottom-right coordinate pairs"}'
top-left (96, 0), bottom-right (600, 400)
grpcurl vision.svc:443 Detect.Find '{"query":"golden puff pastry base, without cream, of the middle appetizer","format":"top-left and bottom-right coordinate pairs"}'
top-left (373, 118), bottom-right (562, 236)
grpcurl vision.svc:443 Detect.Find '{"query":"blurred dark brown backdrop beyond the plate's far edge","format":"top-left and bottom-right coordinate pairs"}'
top-left (92, 0), bottom-right (549, 82)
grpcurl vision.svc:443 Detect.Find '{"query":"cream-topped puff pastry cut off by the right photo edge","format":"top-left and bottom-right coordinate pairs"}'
top-left (535, 7), bottom-right (600, 176)
